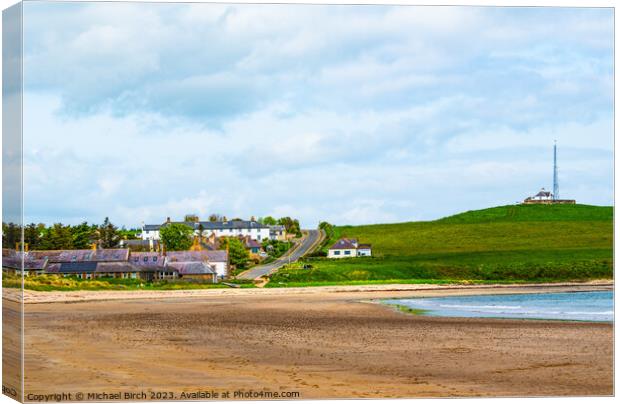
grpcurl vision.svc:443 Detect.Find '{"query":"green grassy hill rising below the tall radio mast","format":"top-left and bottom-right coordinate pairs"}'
top-left (269, 205), bottom-right (613, 287)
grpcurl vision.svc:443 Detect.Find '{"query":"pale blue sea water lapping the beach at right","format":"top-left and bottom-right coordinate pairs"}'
top-left (383, 291), bottom-right (614, 321)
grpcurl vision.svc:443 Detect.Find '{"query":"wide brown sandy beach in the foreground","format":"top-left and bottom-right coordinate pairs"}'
top-left (4, 283), bottom-right (613, 401)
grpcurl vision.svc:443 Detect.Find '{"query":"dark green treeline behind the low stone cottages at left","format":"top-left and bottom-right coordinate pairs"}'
top-left (2, 217), bottom-right (138, 250)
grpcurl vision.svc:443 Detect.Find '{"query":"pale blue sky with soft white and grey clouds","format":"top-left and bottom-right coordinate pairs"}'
top-left (24, 2), bottom-right (613, 228)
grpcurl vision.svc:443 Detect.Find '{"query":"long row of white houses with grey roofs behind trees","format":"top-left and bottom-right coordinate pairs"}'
top-left (141, 218), bottom-right (286, 241)
